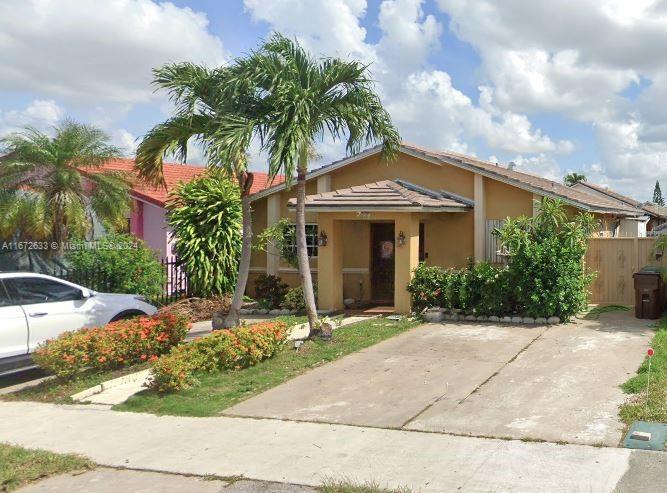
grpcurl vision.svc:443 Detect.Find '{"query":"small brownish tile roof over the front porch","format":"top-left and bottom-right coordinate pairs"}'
top-left (288, 180), bottom-right (473, 211)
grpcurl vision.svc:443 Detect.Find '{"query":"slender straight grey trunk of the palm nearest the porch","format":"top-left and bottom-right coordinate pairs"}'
top-left (296, 145), bottom-right (317, 337)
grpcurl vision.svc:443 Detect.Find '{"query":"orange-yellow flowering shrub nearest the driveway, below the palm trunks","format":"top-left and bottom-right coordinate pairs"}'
top-left (149, 322), bottom-right (288, 392)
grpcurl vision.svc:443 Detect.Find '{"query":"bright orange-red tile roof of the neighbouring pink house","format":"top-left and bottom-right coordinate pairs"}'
top-left (87, 159), bottom-right (284, 207)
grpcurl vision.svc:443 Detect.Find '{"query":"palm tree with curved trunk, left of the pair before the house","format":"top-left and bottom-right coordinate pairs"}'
top-left (136, 63), bottom-right (254, 329)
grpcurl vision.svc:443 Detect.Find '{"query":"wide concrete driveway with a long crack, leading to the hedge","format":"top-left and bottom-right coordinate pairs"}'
top-left (224, 312), bottom-right (652, 446)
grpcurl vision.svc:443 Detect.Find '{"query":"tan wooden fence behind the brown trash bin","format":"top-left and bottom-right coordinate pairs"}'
top-left (586, 238), bottom-right (664, 305)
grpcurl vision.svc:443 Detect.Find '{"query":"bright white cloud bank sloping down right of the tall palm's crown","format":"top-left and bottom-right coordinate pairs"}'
top-left (245, 0), bottom-right (572, 161)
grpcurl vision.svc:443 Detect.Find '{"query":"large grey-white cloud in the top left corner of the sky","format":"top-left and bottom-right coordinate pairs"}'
top-left (0, 0), bottom-right (224, 104)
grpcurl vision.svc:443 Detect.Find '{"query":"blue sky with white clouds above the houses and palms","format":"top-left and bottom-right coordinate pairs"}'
top-left (0, 0), bottom-right (667, 199)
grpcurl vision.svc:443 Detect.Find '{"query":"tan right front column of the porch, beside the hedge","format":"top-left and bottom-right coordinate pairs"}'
top-left (394, 213), bottom-right (419, 313)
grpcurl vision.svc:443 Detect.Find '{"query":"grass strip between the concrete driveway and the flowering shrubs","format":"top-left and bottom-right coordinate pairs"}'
top-left (114, 318), bottom-right (419, 416)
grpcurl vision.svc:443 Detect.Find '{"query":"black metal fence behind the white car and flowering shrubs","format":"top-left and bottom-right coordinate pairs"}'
top-left (53, 257), bottom-right (192, 306)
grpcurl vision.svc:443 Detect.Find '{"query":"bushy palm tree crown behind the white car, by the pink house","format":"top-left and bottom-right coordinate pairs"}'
top-left (0, 120), bottom-right (131, 251)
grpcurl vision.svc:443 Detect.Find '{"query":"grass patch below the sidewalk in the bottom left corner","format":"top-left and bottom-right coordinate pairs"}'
top-left (0, 443), bottom-right (95, 492)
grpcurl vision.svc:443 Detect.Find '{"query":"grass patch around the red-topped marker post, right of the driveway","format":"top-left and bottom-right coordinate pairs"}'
top-left (619, 318), bottom-right (667, 425)
